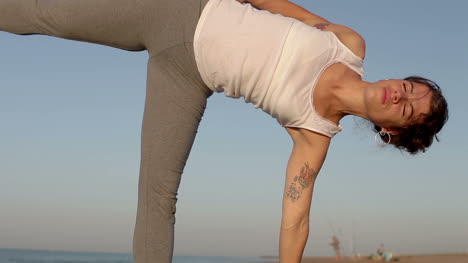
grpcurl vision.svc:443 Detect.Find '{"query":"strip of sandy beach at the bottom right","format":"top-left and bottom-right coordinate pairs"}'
top-left (256, 254), bottom-right (468, 263)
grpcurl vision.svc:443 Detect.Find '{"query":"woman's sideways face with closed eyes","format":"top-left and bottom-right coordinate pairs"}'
top-left (364, 79), bottom-right (432, 129)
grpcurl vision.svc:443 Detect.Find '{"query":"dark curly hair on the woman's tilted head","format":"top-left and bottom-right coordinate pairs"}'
top-left (374, 76), bottom-right (448, 154)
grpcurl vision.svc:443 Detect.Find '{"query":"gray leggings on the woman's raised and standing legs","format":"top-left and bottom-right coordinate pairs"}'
top-left (0, 0), bottom-right (212, 263)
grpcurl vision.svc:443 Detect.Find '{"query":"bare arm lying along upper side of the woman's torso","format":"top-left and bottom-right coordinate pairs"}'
top-left (237, 0), bottom-right (330, 26)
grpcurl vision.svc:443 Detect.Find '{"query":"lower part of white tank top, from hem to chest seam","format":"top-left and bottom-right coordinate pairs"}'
top-left (194, 0), bottom-right (296, 100)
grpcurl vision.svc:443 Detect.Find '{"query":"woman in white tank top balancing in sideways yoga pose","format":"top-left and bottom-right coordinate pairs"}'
top-left (0, 0), bottom-right (448, 263)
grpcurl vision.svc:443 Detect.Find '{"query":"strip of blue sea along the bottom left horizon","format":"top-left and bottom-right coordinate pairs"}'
top-left (0, 248), bottom-right (273, 263)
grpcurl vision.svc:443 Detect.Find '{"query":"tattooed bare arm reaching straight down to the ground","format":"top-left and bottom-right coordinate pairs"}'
top-left (279, 129), bottom-right (330, 263)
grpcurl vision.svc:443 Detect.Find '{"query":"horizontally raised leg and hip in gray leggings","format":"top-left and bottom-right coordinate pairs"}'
top-left (0, 0), bottom-right (208, 53)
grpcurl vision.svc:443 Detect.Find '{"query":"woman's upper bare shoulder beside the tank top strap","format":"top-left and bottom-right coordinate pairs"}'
top-left (307, 21), bottom-right (366, 59)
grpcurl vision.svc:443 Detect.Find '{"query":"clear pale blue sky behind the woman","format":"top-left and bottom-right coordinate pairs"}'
top-left (0, 0), bottom-right (468, 256)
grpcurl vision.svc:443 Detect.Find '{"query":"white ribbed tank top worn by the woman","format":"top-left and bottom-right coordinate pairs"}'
top-left (194, 0), bottom-right (363, 137)
